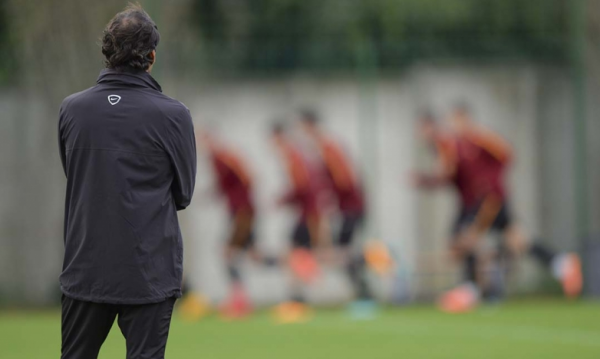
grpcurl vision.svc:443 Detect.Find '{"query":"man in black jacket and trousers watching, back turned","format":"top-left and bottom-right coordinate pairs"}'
top-left (59, 5), bottom-right (196, 359)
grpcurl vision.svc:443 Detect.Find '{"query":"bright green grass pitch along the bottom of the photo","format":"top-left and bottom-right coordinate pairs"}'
top-left (0, 300), bottom-right (600, 359)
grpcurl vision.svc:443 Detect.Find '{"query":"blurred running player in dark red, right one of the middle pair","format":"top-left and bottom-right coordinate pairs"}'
top-left (300, 110), bottom-right (372, 310)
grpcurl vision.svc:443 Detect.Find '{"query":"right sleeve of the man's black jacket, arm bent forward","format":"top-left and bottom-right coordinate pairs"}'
top-left (165, 108), bottom-right (196, 211)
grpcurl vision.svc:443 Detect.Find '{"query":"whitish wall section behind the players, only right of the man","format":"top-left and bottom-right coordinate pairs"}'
top-left (171, 66), bottom-right (556, 302)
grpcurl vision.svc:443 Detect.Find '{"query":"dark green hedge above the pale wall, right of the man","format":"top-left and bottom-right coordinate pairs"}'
top-left (192, 0), bottom-right (569, 70)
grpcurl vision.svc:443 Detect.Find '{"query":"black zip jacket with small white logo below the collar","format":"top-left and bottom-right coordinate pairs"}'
top-left (59, 70), bottom-right (196, 304)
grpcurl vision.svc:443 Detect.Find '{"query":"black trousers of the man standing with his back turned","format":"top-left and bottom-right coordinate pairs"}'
top-left (61, 295), bottom-right (175, 359)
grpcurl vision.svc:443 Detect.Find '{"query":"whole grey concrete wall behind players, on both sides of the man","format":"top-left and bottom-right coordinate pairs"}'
top-left (0, 65), bottom-right (584, 303)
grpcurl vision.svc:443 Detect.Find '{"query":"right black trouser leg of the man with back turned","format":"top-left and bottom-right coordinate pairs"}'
top-left (118, 298), bottom-right (176, 359)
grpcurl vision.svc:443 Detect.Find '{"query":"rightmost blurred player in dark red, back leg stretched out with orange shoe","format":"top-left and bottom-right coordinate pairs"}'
top-left (440, 104), bottom-right (583, 310)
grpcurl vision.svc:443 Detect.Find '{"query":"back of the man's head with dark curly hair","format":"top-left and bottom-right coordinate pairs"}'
top-left (102, 4), bottom-right (160, 71)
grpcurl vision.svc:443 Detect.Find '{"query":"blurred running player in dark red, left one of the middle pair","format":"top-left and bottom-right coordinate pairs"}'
top-left (271, 124), bottom-right (320, 322)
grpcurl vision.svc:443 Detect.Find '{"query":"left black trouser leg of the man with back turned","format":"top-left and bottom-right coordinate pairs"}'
top-left (61, 295), bottom-right (117, 359)
